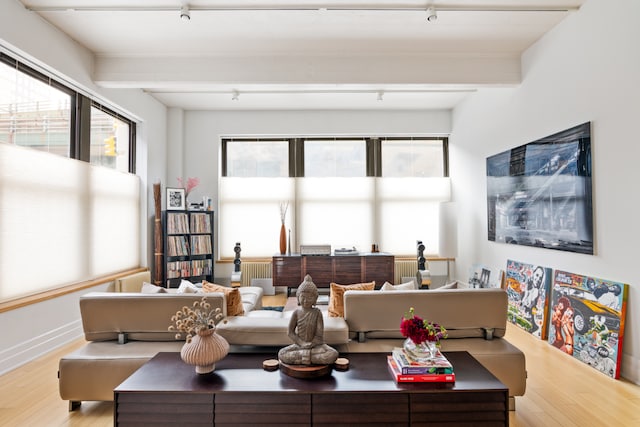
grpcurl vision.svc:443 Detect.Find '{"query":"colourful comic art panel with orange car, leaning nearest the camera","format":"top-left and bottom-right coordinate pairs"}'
top-left (549, 271), bottom-right (628, 379)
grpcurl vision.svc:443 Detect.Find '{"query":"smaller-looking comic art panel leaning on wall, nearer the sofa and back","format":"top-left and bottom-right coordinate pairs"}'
top-left (506, 260), bottom-right (552, 340)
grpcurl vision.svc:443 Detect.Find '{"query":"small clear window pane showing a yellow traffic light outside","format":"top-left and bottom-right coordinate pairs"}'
top-left (90, 107), bottom-right (130, 172)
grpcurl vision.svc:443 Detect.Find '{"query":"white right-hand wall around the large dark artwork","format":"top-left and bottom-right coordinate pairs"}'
top-left (450, 0), bottom-right (640, 382)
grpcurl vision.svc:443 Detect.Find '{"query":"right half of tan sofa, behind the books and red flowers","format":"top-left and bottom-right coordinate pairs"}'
top-left (339, 289), bottom-right (527, 409)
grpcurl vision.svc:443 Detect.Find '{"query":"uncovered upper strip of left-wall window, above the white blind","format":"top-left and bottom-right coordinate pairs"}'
top-left (0, 52), bottom-right (135, 172)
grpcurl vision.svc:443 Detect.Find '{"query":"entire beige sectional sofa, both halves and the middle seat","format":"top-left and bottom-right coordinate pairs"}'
top-left (59, 274), bottom-right (526, 409)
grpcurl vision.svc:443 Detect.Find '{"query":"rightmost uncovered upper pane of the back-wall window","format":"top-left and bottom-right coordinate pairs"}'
top-left (382, 140), bottom-right (444, 177)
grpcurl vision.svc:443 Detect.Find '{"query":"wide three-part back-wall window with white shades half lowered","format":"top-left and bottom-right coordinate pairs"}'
top-left (219, 138), bottom-right (450, 258)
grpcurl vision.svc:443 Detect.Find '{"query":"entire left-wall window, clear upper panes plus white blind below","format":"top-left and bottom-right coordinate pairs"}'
top-left (0, 52), bottom-right (141, 302)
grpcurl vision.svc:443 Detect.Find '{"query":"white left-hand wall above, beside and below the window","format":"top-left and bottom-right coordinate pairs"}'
top-left (0, 0), bottom-right (167, 373)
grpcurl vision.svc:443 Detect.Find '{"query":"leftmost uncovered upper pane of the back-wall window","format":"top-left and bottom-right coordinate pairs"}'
top-left (226, 141), bottom-right (289, 177)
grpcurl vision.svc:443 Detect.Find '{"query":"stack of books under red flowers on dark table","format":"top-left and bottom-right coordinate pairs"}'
top-left (387, 348), bottom-right (456, 383)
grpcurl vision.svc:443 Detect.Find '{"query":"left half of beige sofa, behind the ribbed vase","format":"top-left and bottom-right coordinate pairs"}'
top-left (58, 287), bottom-right (262, 409)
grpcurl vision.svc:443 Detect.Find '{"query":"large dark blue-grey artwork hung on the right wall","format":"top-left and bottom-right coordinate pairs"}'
top-left (487, 123), bottom-right (594, 254)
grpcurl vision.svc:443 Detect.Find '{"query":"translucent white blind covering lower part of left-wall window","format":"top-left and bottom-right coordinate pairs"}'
top-left (0, 143), bottom-right (140, 300)
